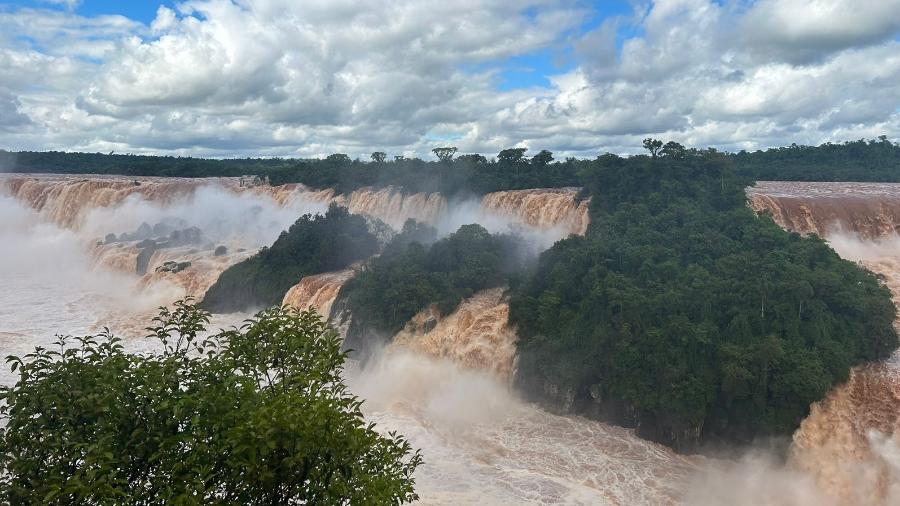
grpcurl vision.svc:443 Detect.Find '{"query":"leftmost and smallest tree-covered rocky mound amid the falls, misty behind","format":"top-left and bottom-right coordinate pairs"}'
top-left (202, 205), bottom-right (378, 313)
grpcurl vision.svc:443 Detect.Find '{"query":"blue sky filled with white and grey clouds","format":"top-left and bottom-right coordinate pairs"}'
top-left (0, 0), bottom-right (900, 158)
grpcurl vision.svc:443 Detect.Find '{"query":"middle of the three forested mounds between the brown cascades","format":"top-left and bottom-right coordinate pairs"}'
top-left (336, 220), bottom-right (526, 351)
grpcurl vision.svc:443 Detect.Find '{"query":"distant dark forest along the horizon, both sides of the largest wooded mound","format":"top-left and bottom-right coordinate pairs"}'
top-left (0, 136), bottom-right (900, 195)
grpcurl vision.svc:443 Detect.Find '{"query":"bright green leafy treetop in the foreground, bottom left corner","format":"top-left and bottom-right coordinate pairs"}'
top-left (0, 301), bottom-right (421, 505)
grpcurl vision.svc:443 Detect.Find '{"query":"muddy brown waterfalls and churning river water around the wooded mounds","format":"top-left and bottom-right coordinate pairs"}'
top-left (0, 175), bottom-right (900, 505)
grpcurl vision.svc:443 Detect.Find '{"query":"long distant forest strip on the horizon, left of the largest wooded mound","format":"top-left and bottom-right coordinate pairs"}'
top-left (0, 148), bottom-right (586, 195)
